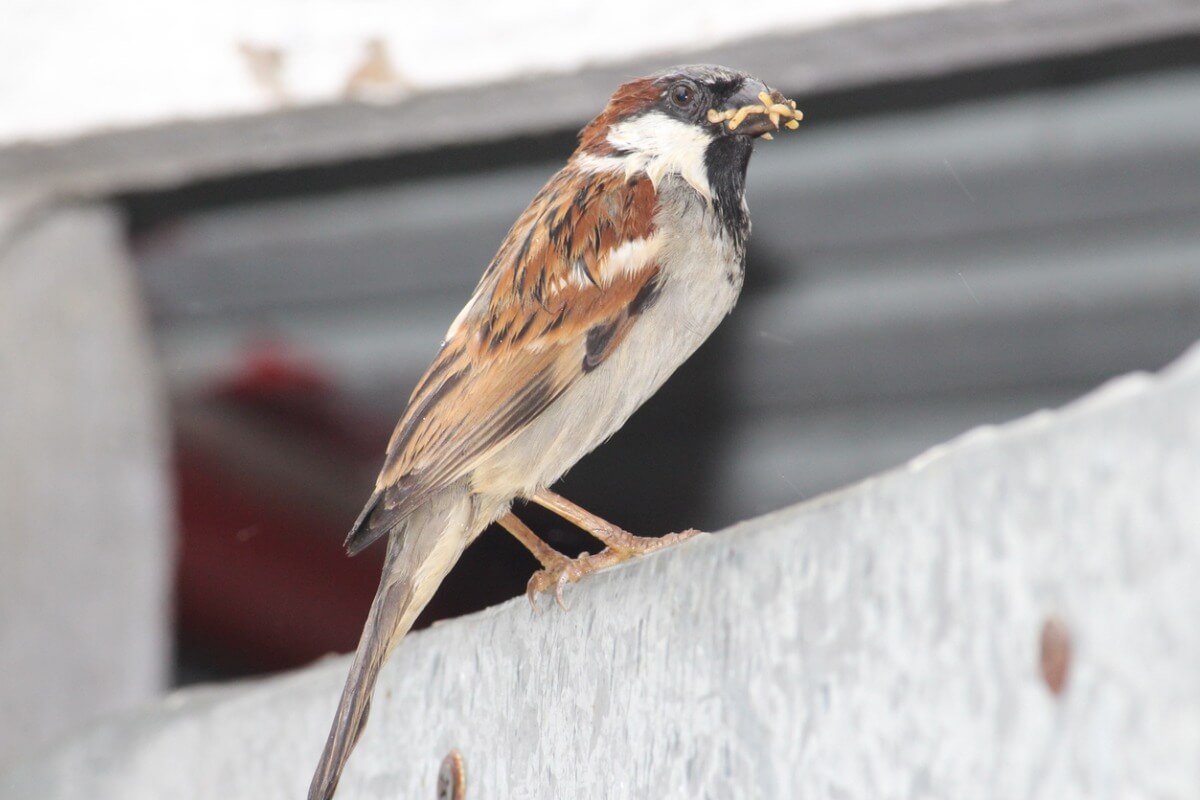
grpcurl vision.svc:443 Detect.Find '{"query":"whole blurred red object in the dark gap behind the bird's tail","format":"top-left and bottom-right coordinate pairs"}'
top-left (175, 341), bottom-right (386, 672)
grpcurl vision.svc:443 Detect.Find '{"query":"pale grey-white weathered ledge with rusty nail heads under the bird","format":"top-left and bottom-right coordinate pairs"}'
top-left (0, 351), bottom-right (1200, 800)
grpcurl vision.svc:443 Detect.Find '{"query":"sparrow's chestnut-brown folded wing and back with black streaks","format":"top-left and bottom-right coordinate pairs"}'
top-left (377, 166), bottom-right (658, 511)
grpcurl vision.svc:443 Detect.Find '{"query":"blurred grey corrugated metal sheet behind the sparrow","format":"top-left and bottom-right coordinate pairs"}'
top-left (142, 65), bottom-right (1200, 515)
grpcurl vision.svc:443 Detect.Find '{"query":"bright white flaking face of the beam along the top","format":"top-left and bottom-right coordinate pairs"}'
top-left (0, 0), bottom-right (989, 144)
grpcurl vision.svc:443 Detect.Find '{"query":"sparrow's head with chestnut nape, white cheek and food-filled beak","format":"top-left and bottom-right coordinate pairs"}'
top-left (575, 65), bottom-right (800, 199)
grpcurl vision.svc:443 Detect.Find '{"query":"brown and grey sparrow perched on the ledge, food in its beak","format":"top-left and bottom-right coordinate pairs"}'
top-left (308, 65), bottom-right (803, 800)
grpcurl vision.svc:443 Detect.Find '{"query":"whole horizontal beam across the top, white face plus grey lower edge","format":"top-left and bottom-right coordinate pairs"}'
top-left (0, 0), bottom-right (1200, 193)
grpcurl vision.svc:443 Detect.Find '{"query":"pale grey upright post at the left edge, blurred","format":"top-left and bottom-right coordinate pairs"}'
top-left (0, 199), bottom-right (172, 762)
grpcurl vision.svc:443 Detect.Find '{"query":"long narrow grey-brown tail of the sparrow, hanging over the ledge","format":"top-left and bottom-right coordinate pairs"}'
top-left (308, 498), bottom-right (475, 800)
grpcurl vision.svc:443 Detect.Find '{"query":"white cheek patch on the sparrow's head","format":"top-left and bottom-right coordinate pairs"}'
top-left (605, 112), bottom-right (713, 199)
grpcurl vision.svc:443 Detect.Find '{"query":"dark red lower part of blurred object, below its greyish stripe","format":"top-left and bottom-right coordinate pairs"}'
top-left (176, 449), bottom-right (382, 670)
